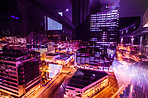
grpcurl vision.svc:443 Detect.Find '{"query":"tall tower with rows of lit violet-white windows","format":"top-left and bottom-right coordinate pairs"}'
top-left (90, 10), bottom-right (119, 46)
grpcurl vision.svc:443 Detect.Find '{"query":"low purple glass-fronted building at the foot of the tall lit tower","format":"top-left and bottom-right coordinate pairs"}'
top-left (74, 47), bottom-right (112, 70)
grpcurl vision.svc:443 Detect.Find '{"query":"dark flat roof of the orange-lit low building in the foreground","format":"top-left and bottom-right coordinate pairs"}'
top-left (68, 69), bottom-right (108, 89)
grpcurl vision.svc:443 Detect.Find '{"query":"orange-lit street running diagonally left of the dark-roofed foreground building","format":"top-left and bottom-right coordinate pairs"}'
top-left (28, 62), bottom-right (76, 98)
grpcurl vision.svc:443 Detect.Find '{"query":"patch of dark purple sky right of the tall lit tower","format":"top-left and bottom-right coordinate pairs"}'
top-left (119, 0), bottom-right (148, 17)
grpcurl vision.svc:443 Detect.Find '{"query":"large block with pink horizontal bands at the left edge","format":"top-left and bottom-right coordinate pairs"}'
top-left (0, 50), bottom-right (40, 97)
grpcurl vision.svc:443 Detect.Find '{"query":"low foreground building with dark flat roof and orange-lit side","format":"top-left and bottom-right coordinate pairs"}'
top-left (65, 69), bottom-right (109, 98)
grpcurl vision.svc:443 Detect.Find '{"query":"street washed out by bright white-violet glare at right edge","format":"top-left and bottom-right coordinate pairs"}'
top-left (113, 46), bottom-right (148, 98)
